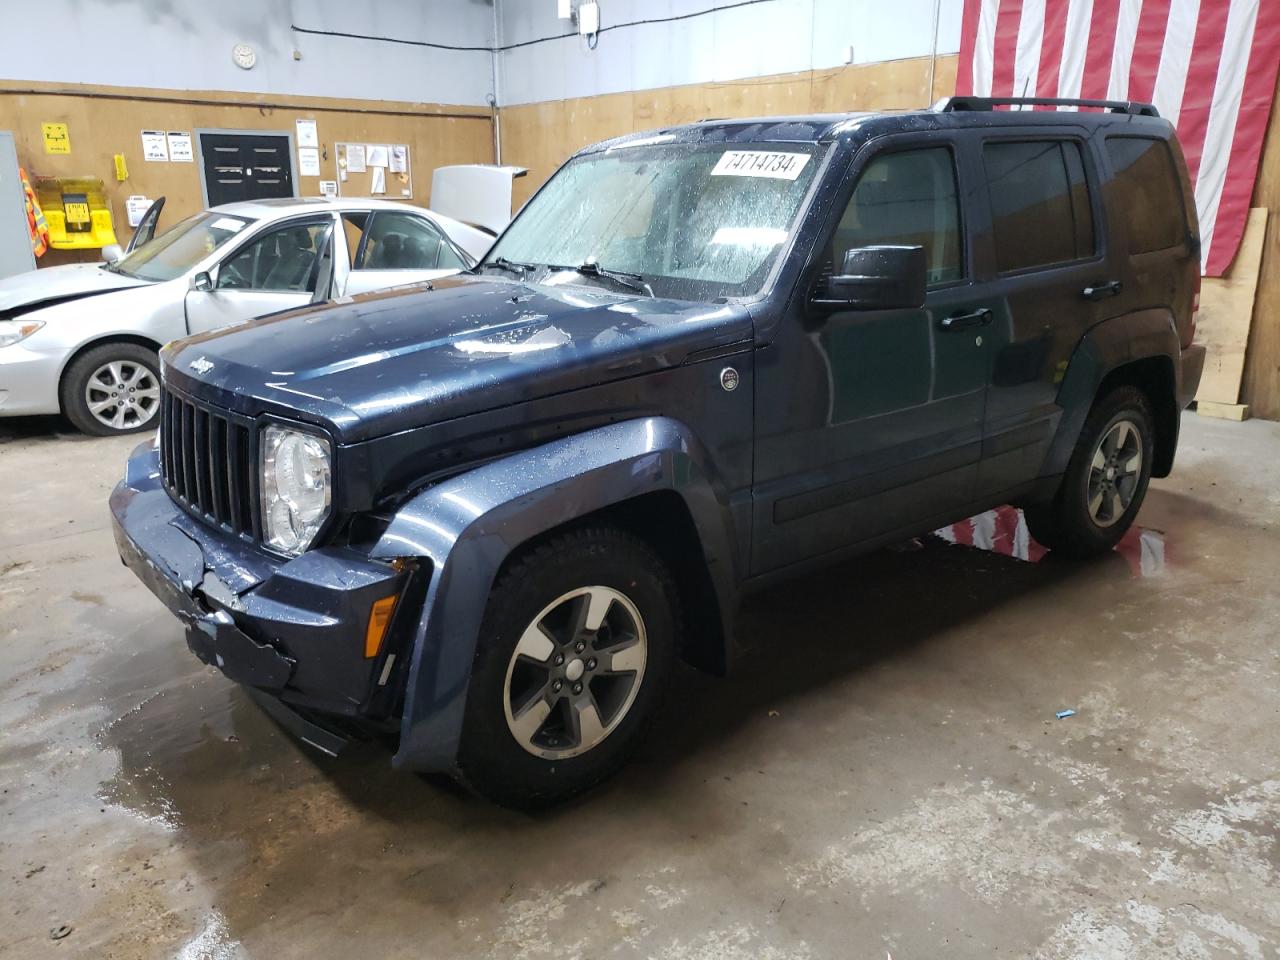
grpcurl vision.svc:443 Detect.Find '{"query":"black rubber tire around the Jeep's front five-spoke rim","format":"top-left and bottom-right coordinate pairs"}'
top-left (456, 526), bottom-right (681, 809)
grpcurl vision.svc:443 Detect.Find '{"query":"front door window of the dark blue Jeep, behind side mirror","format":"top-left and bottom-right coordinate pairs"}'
top-left (831, 147), bottom-right (963, 284)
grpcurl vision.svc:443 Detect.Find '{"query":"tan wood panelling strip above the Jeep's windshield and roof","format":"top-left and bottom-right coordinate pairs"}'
top-left (498, 56), bottom-right (959, 206)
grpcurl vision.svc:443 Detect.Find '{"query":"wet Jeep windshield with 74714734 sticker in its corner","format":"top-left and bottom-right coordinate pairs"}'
top-left (481, 142), bottom-right (818, 300)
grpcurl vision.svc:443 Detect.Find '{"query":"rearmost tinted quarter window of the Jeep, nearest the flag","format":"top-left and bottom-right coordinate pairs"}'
top-left (1106, 137), bottom-right (1187, 253)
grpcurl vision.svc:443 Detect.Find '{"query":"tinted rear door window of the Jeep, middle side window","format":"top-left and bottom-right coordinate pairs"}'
top-left (982, 140), bottom-right (1096, 273)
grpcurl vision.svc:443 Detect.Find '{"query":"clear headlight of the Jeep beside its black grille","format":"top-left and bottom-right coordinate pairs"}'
top-left (261, 424), bottom-right (333, 557)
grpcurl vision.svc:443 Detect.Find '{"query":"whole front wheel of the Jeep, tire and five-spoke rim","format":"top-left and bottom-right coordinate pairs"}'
top-left (457, 526), bottom-right (680, 808)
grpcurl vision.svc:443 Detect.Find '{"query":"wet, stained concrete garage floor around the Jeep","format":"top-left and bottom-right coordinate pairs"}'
top-left (0, 415), bottom-right (1280, 960)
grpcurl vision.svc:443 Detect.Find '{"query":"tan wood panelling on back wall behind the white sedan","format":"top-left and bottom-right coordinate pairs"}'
top-left (0, 81), bottom-right (494, 266)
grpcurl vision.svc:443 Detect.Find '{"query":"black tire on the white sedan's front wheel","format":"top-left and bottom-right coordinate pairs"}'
top-left (59, 342), bottom-right (160, 436)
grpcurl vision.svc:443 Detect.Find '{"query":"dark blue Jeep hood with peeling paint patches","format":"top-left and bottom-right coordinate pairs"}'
top-left (163, 275), bottom-right (751, 443)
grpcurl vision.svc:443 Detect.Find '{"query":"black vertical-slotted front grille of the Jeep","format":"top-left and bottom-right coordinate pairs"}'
top-left (160, 388), bottom-right (257, 539)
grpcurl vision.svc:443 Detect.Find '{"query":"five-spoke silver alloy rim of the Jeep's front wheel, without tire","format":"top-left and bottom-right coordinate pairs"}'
top-left (503, 586), bottom-right (648, 760)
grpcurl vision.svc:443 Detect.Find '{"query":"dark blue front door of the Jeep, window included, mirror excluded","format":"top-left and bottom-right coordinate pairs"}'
top-left (751, 136), bottom-right (991, 573)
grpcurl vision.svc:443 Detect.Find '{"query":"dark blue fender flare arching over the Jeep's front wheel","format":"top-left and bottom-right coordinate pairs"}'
top-left (372, 417), bottom-right (737, 771)
